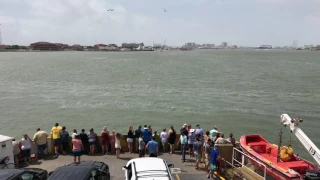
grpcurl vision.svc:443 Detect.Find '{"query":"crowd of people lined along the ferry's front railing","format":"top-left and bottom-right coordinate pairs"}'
top-left (14, 123), bottom-right (235, 178)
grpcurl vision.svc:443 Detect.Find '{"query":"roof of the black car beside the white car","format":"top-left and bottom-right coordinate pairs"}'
top-left (49, 166), bottom-right (95, 180)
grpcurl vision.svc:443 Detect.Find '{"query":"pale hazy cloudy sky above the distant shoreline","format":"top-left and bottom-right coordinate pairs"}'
top-left (0, 0), bottom-right (320, 46)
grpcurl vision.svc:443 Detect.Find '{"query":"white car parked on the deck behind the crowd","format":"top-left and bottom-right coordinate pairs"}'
top-left (122, 157), bottom-right (179, 180)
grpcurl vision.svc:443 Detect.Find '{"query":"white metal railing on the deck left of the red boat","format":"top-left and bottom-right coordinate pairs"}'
top-left (232, 148), bottom-right (267, 179)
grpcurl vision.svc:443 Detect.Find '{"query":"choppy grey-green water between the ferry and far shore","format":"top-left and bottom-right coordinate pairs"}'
top-left (0, 50), bottom-right (320, 160)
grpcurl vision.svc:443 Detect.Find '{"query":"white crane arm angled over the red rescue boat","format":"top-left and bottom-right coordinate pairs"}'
top-left (280, 114), bottom-right (320, 165)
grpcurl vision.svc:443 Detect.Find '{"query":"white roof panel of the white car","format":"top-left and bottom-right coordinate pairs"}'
top-left (129, 157), bottom-right (168, 173)
